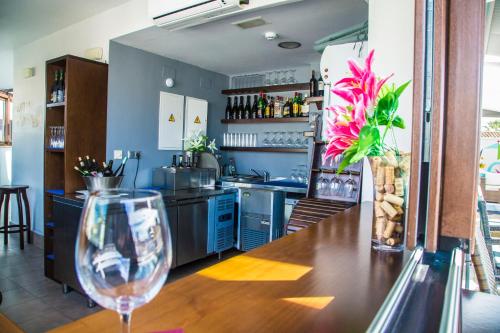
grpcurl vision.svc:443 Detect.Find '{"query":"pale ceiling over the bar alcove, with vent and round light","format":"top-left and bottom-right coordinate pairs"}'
top-left (115, 0), bottom-right (368, 75)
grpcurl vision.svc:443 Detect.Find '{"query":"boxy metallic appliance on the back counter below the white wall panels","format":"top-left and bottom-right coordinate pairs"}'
top-left (153, 167), bottom-right (216, 190)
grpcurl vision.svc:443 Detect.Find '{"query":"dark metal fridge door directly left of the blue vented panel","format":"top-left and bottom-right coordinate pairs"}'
top-left (177, 197), bottom-right (208, 266)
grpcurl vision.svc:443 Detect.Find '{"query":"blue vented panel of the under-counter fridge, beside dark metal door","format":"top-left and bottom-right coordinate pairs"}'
top-left (207, 193), bottom-right (236, 255)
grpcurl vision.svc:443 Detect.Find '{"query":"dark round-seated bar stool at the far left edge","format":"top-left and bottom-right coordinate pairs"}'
top-left (0, 185), bottom-right (32, 250)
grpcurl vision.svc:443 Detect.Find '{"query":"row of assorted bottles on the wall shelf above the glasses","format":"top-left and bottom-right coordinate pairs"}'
top-left (225, 92), bottom-right (309, 119)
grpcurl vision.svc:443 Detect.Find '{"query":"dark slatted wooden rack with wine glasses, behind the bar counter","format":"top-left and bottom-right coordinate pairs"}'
top-left (286, 141), bottom-right (363, 234)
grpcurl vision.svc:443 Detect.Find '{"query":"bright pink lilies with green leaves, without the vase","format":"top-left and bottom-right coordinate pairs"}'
top-left (323, 50), bottom-right (411, 173)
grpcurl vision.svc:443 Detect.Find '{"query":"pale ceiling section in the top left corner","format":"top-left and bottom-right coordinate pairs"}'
top-left (0, 0), bottom-right (132, 51)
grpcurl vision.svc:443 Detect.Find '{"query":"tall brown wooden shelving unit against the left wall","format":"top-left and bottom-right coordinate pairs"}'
top-left (44, 55), bottom-right (108, 280)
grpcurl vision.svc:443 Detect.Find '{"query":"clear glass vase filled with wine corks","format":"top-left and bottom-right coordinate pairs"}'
top-left (368, 151), bottom-right (410, 251)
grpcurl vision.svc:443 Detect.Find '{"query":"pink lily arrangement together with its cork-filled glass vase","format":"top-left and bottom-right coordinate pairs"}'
top-left (323, 50), bottom-right (411, 251)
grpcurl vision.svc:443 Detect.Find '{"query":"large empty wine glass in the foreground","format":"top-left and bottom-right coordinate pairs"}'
top-left (75, 189), bottom-right (172, 332)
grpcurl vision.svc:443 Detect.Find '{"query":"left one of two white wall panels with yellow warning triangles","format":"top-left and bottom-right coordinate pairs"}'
top-left (158, 91), bottom-right (184, 150)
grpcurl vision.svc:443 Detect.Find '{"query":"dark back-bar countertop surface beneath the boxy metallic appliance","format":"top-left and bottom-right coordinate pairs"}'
top-left (54, 186), bottom-right (238, 206)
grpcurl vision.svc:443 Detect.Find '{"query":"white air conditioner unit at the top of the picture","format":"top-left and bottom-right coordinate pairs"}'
top-left (148, 0), bottom-right (246, 31)
